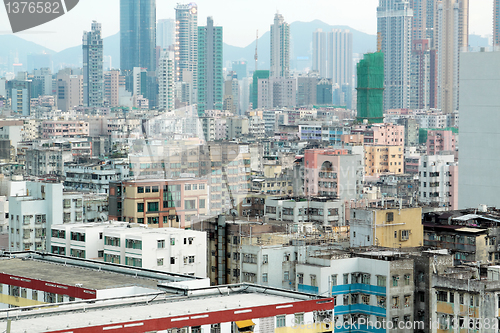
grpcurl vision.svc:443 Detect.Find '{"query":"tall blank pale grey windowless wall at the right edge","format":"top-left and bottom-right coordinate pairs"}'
top-left (458, 52), bottom-right (500, 209)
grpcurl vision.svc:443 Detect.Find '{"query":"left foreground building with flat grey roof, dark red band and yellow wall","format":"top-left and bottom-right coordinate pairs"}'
top-left (0, 252), bottom-right (208, 308)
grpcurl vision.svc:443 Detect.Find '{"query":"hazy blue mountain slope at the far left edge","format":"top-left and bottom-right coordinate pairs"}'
top-left (0, 35), bottom-right (55, 71)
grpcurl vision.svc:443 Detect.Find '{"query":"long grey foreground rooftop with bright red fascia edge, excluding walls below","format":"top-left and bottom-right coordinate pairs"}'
top-left (0, 284), bottom-right (333, 333)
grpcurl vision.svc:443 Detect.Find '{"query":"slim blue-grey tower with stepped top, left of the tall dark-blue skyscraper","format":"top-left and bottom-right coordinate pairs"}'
top-left (83, 21), bottom-right (104, 106)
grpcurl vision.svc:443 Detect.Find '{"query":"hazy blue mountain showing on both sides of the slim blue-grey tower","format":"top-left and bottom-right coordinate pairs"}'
top-left (52, 33), bottom-right (120, 72)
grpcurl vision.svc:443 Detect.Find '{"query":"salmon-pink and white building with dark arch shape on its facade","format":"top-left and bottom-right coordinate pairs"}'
top-left (304, 149), bottom-right (363, 200)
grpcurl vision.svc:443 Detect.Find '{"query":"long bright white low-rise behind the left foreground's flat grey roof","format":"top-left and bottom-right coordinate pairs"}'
top-left (50, 222), bottom-right (207, 277)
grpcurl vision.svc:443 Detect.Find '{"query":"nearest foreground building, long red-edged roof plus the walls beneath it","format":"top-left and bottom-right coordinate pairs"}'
top-left (0, 280), bottom-right (334, 333)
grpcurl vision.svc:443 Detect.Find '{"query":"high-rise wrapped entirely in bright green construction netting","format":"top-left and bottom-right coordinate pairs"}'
top-left (356, 52), bottom-right (384, 123)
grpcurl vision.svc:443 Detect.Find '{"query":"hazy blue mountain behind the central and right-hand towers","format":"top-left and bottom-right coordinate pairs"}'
top-left (224, 20), bottom-right (377, 71)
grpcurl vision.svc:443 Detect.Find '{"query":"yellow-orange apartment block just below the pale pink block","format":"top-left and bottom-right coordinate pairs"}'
top-left (365, 146), bottom-right (404, 176)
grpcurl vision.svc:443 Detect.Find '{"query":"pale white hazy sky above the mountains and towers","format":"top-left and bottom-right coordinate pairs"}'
top-left (0, 0), bottom-right (493, 51)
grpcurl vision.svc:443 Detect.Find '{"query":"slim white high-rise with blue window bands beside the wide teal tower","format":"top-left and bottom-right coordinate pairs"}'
top-left (175, 2), bottom-right (198, 104)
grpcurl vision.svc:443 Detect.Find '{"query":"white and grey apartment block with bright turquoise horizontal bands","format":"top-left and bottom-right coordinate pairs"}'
top-left (296, 251), bottom-right (415, 332)
